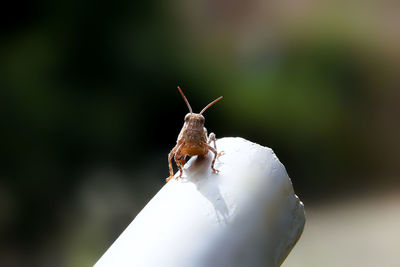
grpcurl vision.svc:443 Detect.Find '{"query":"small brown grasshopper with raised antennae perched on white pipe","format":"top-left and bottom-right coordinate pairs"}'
top-left (166, 86), bottom-right (222, 182)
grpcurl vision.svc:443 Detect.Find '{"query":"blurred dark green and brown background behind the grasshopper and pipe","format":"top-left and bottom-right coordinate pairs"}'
top-left (0, 0), bottom-right (400, 267)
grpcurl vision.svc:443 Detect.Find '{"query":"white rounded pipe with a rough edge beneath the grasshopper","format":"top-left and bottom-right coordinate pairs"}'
top-left (95, 138), bottom-right (305, 267)
